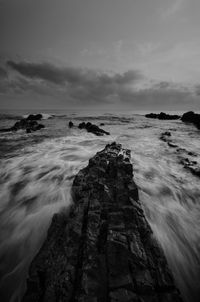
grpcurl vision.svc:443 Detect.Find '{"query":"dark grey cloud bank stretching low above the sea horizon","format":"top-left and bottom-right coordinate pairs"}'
top-left (0, 60), bottom-right (200, 111)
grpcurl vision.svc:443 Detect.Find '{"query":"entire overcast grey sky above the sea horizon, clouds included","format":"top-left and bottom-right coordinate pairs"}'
top-left (0, 0), bottom-right (200, 111)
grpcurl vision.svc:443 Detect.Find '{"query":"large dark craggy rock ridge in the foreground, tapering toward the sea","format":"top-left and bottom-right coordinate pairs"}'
top-left (23, 143), bottom-right (182, 302)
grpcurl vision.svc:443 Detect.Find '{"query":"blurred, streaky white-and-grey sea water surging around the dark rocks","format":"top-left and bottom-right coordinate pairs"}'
top-left (0, 112), bottom-right (200, 302)
